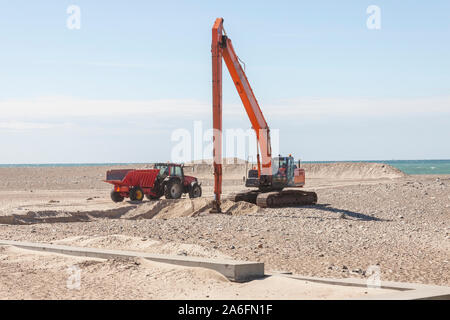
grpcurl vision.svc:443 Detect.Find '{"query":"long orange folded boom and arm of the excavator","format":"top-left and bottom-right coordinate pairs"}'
top-left (211, 18), bottom-right (272, 212)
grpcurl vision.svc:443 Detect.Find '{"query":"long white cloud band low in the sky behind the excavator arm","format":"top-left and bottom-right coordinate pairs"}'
top-left (0, 97), bottom-right (450, 123)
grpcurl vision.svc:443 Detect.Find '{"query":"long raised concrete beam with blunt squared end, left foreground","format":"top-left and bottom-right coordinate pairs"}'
top-left (0, 240), bottom-right (264, 282)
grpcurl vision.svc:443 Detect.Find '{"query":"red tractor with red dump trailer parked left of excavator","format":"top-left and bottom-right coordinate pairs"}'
top-left (104, 163), bottom-right (202, 202)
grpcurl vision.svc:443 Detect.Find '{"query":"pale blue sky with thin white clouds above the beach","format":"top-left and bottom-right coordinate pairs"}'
top-left (0, 0), bottom-right (450, 164)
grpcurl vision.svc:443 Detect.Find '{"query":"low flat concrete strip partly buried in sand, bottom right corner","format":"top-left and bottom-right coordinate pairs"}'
top-left (266, 272), bottom-right (450, 300)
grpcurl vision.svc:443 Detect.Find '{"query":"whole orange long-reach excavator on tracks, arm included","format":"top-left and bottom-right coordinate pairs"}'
top-left (210, 18), bottom-right (317, 213)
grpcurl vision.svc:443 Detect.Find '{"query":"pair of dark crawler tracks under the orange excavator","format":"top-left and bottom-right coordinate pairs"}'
top-left (229, 190), bottom-right (317, 208)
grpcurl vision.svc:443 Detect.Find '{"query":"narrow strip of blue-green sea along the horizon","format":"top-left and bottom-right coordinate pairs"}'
top-left (0, 160), bottom-right (450, 174)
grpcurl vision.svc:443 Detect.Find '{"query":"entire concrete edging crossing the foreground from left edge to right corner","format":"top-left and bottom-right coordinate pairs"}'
top-left (0, 240), bottom-right (450, 300)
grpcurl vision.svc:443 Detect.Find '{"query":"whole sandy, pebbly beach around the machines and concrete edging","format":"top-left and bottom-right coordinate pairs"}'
top-left (0, 163), bottom-right (450, 299)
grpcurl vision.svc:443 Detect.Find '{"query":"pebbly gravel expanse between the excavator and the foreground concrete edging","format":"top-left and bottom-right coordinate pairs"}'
top-left (0, 176), bottom-right (450, 286)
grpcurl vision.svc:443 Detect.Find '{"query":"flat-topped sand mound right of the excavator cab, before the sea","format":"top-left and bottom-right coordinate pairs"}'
top-left (302, 162), bottom-right (406, 180)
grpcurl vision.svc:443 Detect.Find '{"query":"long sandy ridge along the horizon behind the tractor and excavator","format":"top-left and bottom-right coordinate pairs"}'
top-left (0, 161), bottom-right (405, 192)
